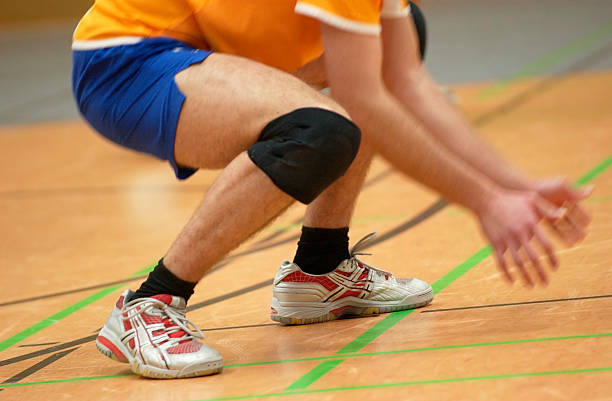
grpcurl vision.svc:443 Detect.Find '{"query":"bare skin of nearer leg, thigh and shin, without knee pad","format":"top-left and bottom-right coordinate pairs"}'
top-left (164, 54), bottom-right (346, 282)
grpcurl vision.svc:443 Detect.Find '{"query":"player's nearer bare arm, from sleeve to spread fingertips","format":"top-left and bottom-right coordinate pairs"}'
top-left (321, 24), bottom-right (572, 284)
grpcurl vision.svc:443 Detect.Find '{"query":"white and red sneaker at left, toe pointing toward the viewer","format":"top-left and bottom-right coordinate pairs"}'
top-left (96, 290), bottom-right (223, 379)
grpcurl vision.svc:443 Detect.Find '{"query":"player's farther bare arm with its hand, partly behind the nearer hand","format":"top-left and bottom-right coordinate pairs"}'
top-left (382, 14), bottom-right (592, 223)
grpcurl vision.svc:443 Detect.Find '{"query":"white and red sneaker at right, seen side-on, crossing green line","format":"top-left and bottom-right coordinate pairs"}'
top-left (270, 233), bottom-right (433, 324)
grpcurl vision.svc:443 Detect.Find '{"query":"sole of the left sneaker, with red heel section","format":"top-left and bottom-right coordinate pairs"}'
top-left (96, 327), bottom-right (223, 379)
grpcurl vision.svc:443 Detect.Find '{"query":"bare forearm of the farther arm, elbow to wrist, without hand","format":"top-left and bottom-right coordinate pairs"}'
top-left (386, 68), bottom-right (532, 190)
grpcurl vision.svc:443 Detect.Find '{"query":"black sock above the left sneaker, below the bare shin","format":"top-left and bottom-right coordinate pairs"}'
top-left (130, 259), bottom-right (197, 302)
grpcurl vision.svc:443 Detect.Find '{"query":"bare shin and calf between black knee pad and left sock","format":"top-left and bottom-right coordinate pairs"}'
top-left (164, 152), bottom-right (293, 282)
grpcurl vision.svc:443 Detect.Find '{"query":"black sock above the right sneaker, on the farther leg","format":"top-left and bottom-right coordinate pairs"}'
top-left (293, 227), bottom-right (350, 274)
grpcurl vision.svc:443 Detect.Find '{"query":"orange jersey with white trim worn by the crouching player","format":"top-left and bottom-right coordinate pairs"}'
top-left (72, 0), bottom-right (409, 72)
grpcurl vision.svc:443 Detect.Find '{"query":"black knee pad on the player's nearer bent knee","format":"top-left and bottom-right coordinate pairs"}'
top-left (248, 108), bottom-right (361, 204)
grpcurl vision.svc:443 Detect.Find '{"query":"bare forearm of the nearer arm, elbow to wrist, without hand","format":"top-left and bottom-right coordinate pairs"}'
top-left (332, 86), bottom-right (499, 211)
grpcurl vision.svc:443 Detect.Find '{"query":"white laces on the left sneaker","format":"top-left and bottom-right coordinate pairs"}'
top-left (122, 298), bottom-right (204, 343)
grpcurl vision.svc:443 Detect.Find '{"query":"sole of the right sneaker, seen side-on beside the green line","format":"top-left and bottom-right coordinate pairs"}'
top-left (270, 288), bottom-right (433, 325)
